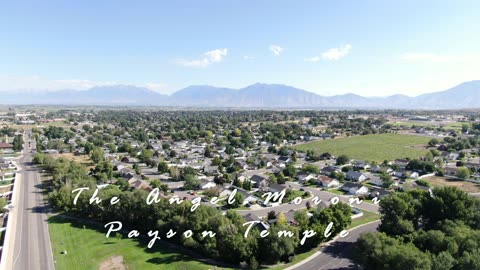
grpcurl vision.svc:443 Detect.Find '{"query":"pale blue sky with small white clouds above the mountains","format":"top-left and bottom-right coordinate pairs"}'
top-left (0, 0), bottom-right (480, 96)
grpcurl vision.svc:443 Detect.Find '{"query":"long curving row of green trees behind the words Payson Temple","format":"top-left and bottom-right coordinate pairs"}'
top-left (34, 154), bottom-right (351, 269)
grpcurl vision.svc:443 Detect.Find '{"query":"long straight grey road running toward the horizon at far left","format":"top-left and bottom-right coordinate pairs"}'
top-left (6, 132), bottom-right (55, 270)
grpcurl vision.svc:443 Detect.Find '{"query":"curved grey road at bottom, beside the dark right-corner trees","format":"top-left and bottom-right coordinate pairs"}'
top-left (287, 221), bottom-right (380, 270)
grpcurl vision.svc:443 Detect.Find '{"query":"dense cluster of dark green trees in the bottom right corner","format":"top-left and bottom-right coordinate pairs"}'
top-left (356, 187), bottom-right (480, 270)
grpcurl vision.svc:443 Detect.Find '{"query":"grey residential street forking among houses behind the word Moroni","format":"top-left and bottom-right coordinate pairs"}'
top-left (237, 182), bottom-right (379, 217)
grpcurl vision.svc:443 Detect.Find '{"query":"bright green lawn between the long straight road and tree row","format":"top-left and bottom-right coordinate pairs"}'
top-left (49, 216), bottom-right (226, 270)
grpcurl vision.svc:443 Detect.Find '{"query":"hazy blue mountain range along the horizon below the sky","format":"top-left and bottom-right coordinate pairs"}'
top-left (0, 81), bottom-right (480, 109)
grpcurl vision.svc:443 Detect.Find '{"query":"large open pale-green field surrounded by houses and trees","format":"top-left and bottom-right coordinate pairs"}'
top-left (293, 133), bottom-right (431, 162)
